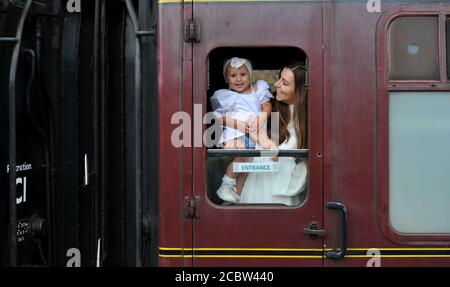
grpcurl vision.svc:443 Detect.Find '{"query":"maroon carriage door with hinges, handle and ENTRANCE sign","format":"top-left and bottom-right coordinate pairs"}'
top-left (190, 1), bottom-right (323, 266)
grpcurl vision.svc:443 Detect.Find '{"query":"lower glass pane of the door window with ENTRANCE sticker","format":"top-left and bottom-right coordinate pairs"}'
top-left (206, 157), bottom-right (308, 206)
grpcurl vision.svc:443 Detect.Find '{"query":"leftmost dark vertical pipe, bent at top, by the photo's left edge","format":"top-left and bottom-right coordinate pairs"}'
top-left (0, 0), bottom-right (32, 267)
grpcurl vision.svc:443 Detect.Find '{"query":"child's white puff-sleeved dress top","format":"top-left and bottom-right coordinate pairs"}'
top-left (211, 80), bottom-right (273, 146)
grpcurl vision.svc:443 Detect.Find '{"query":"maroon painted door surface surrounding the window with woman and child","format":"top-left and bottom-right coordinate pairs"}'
top-left (193, 3), bottom-right (323, 266)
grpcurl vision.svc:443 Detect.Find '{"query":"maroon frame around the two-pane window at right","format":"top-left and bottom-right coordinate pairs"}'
top-left (375, 3), bottom-right (450, 245)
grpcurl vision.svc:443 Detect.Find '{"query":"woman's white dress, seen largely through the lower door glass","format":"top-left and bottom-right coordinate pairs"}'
top-left (239, 107), bottom-right (308, 206)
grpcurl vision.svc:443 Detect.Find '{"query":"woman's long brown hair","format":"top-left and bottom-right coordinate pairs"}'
top-left (274, 62), bottom-right (308, 149)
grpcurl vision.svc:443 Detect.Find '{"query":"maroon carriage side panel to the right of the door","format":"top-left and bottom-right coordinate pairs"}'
top-left (324, 3), bottom-right (450, 266)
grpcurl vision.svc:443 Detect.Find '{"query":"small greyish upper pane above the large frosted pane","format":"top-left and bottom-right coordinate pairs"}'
top-left (389, 17), bottom-right (439, 80)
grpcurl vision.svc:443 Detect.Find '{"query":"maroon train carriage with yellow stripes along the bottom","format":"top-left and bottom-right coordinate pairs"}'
top-left (158, 0), bottom-right (450, 266)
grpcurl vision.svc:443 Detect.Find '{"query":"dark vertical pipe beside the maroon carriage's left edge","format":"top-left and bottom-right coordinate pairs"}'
top-left (125, 0), bottom-right (155, 266)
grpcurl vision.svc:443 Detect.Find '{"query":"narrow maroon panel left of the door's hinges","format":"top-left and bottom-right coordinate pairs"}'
top-left (158, 5), bottom-right (192, 266)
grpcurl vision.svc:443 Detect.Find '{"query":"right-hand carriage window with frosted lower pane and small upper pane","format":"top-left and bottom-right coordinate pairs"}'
top-left (378, 11), bottom-right (450, 238)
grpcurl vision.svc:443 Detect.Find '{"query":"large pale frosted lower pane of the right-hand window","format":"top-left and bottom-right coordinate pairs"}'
top-left (389, 92), bottom-right (450, 233)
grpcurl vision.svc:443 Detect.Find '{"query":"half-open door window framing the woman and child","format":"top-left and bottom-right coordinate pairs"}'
top-left (206, 48), bottom-right (308, 206)
